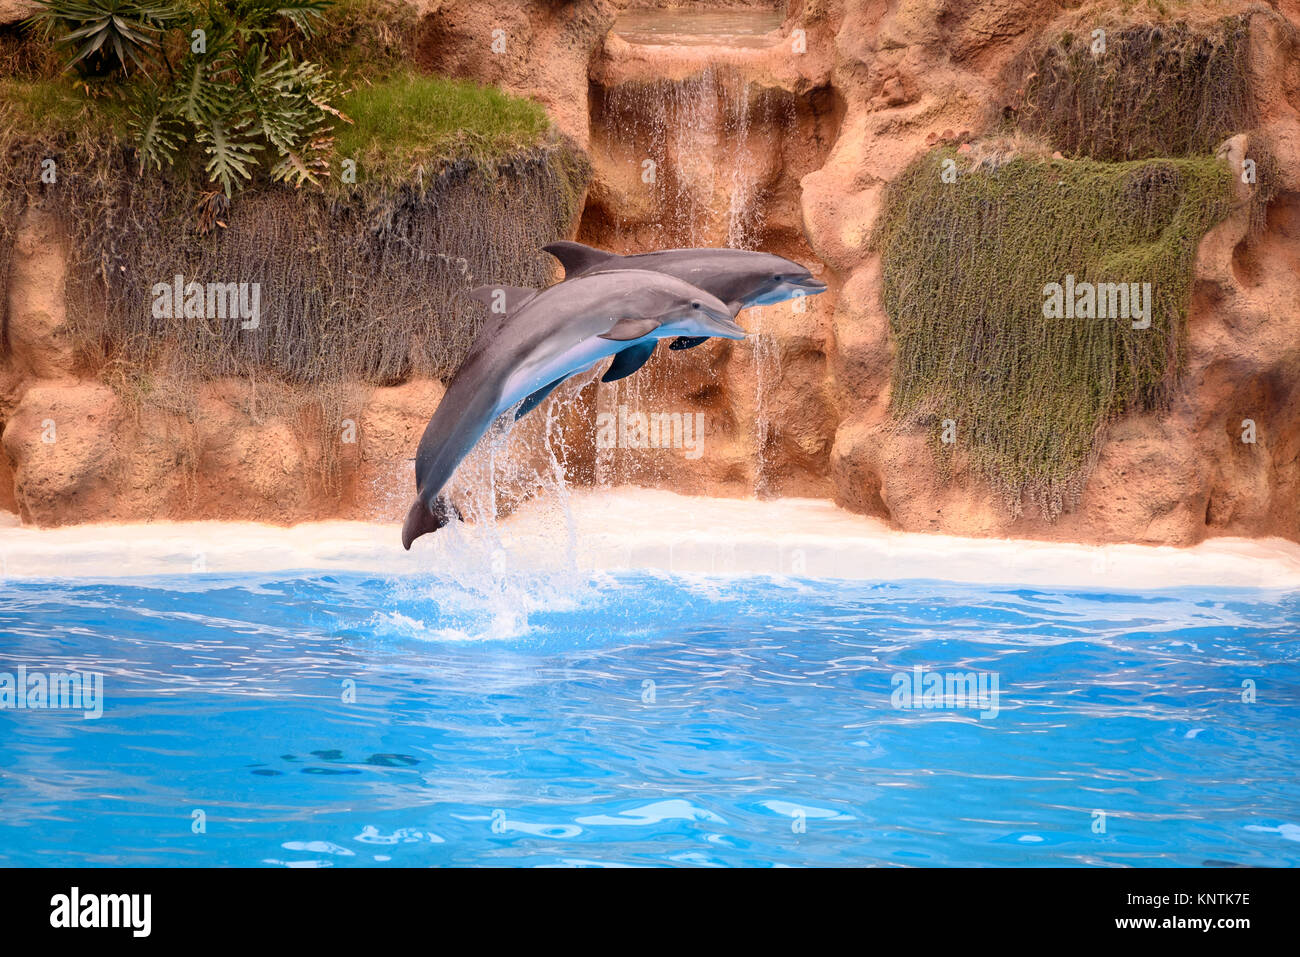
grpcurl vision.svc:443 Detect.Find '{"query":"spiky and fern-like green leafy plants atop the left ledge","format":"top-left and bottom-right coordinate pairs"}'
top-left (35, 0), bottom-right (347, 199)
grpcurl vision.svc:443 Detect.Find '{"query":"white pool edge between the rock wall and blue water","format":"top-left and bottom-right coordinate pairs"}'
top-left (0, 489), bottom-right (1300, 590)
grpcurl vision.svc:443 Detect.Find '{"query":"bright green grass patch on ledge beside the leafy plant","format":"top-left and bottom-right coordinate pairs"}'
top-left (335, 72), bottom-right (550, 187)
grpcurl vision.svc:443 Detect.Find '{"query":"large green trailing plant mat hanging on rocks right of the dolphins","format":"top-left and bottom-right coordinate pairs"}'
top-left (875, 150), bottom-right (1232, 518)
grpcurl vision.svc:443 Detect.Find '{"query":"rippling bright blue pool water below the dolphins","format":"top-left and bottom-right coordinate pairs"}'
top-left (0, 573), bottom-right (1300, 866)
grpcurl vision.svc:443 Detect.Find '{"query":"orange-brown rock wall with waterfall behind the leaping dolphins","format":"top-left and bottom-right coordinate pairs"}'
top-left (0, 0), bottom-right (1300, 545)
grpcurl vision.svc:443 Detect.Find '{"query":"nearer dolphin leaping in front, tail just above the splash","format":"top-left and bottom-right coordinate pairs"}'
top-left (402, 269), bottom-right (745, 549)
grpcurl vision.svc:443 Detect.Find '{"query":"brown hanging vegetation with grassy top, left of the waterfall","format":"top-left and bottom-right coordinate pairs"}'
top-left (0, 0), bottom-right (589, 384)
